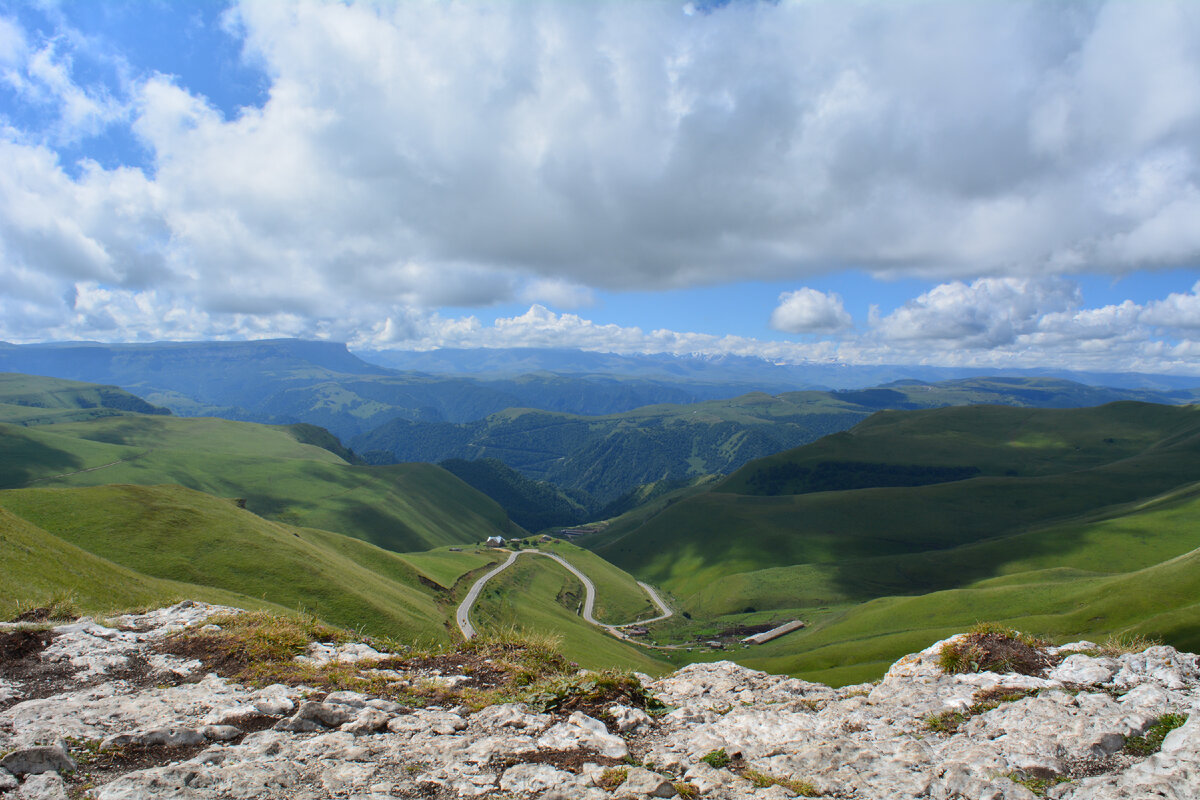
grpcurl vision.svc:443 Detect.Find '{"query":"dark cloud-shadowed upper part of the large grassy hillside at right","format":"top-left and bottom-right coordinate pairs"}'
top-left (588, 403), bottom-right (1200, 602)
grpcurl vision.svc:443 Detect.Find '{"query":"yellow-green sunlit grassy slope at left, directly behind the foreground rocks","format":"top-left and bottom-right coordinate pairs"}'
top-left (0, 486), bottom-right (458, 640)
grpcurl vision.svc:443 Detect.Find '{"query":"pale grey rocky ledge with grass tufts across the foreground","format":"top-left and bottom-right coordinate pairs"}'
top-left (0, 602), bottom-right (1200, 800)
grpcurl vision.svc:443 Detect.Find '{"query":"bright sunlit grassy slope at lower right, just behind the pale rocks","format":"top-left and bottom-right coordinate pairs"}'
top-left (729, 485), bottom-right (1200, 682)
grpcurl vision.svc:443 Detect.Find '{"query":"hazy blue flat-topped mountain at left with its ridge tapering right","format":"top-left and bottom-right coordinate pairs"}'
top-left (0, 339), bottom-right (801, 440)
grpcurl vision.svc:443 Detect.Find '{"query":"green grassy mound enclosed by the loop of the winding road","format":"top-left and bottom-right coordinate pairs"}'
top-left (472, 557), bottom-right (667, 674)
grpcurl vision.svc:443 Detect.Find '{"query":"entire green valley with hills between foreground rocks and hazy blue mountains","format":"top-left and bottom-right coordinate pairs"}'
top-left (0, 357), bottom-right (1200, 685)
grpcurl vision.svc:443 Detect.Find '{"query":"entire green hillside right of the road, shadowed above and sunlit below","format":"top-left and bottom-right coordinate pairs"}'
top-left (599, 403), bottom-right (1200, 682)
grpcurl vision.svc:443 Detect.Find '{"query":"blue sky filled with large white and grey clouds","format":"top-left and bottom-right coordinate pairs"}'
top-left (0, 0), bottom-right (1200, 374)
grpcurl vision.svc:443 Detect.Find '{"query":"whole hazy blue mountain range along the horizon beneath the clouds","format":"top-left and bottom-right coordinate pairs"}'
top-left (0, 339), bottom-right (1200, 448)
